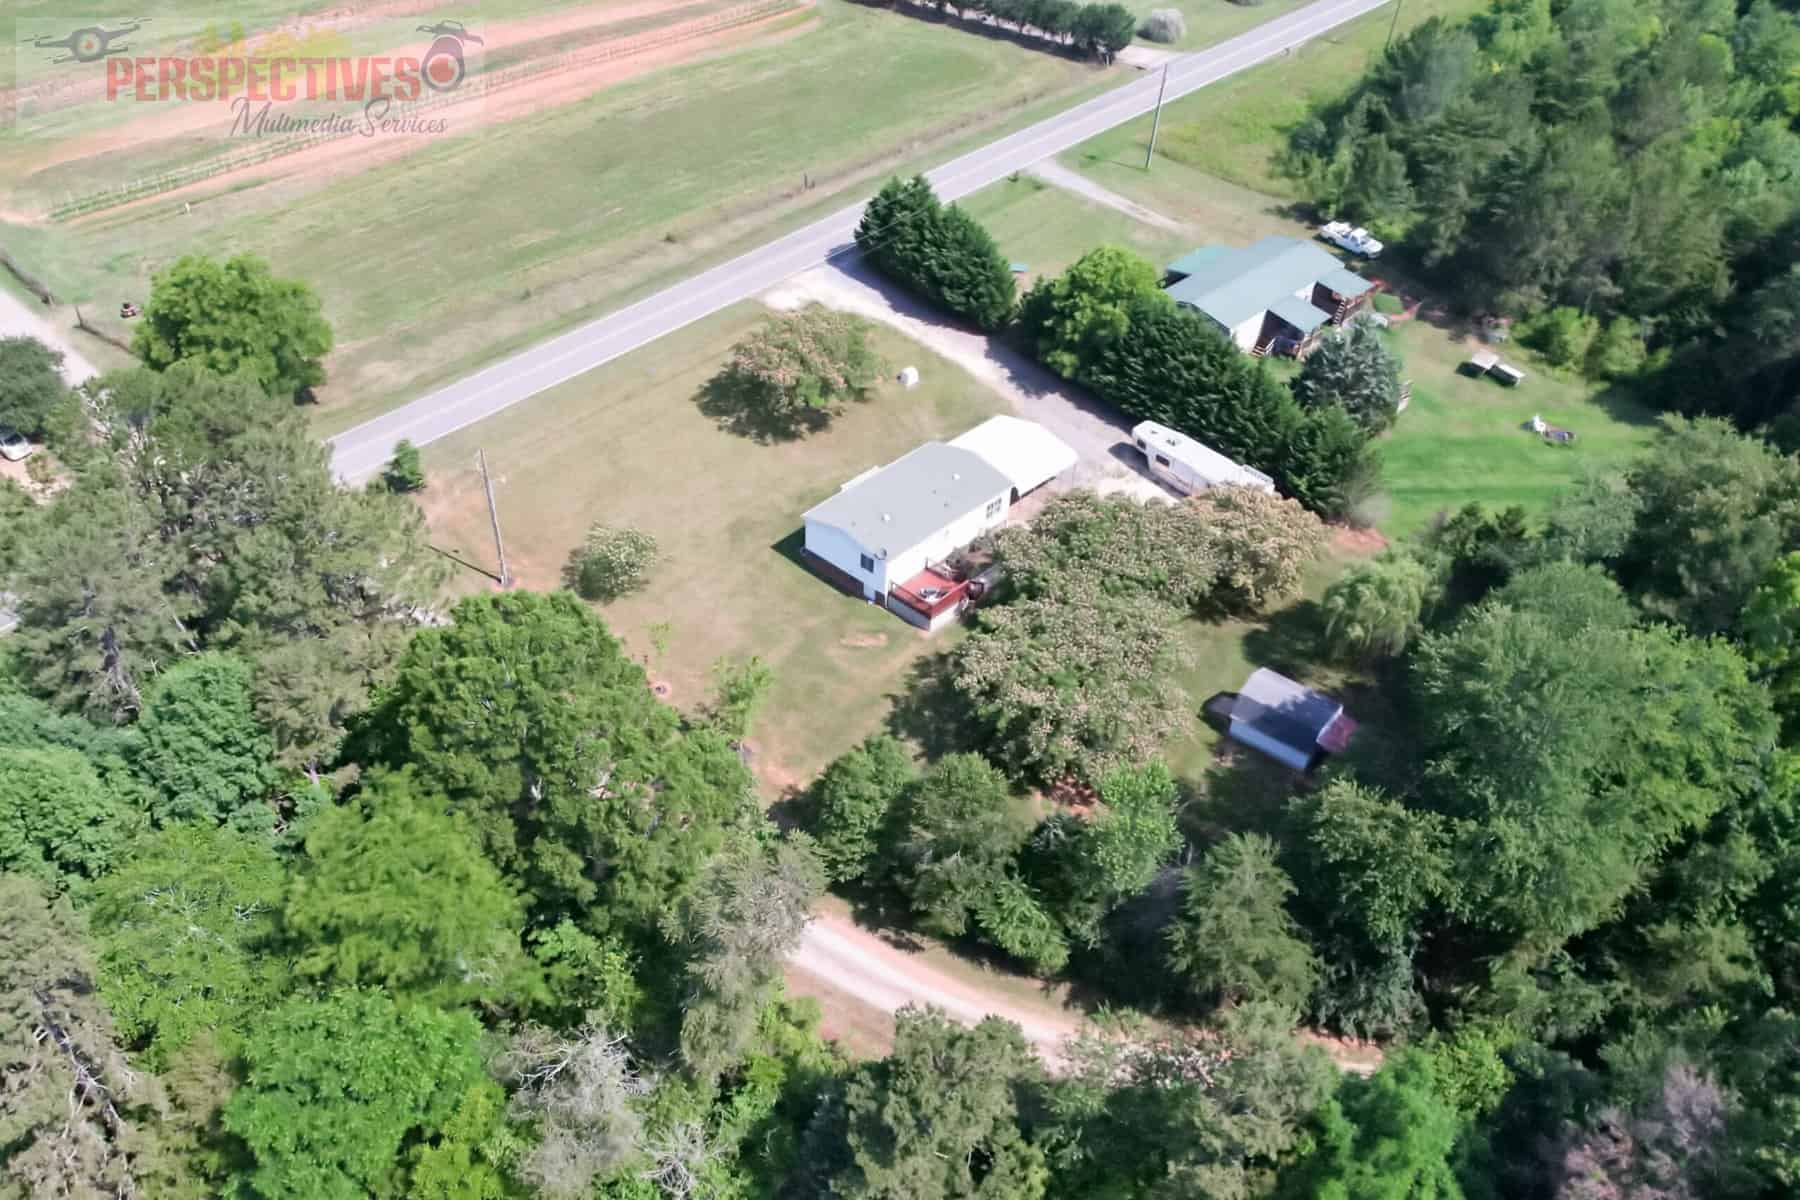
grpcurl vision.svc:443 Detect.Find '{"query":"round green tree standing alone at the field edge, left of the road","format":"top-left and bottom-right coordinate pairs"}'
top-left (131, 254), bottom-right (331, 399)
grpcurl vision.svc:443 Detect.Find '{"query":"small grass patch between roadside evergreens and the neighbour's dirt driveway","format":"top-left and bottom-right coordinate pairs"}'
top-left (958, 175), bottom-right (1193, 279)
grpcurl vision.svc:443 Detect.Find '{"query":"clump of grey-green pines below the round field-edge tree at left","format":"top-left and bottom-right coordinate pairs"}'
top-left (7, 363), bottom-right (441, 755)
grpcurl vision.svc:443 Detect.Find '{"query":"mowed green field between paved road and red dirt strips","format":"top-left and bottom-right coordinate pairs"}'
top-left (0, 0), bottom-right (1129, 432)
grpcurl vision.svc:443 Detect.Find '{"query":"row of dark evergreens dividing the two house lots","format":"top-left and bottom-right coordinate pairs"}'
top-left (857, 176), bottom-right (1400, 516)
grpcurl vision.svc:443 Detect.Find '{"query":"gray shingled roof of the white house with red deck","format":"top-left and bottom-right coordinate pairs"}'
top-left (806, 441), bottom-right (1012, 554)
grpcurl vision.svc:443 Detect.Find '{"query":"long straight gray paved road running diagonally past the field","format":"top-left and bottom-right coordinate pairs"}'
top-left (331, 0), bottom-right (1388, 480)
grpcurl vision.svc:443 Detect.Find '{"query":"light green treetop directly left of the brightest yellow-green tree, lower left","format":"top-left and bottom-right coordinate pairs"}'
top-left (88, 824), bottom-right (290, 1067)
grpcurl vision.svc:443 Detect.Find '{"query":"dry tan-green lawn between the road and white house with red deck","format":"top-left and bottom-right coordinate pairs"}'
top-left (421, 304), bottom-right (1003, 799)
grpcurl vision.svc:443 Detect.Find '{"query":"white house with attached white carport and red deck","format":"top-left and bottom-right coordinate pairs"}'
top-left (803, 417), bottom-right (1075, 630)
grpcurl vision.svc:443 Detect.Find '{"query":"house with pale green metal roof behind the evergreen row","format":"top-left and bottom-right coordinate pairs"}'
top-left (1165, 236), bottom-right (1375, 354)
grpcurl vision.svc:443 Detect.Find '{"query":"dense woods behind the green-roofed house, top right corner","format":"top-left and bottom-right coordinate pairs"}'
top-left (1285, 0), bottom-right (1800, 448)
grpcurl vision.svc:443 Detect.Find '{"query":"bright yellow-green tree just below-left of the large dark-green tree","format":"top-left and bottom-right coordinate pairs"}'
top-left (281, 775), bottom-right (529, 1006)
